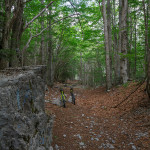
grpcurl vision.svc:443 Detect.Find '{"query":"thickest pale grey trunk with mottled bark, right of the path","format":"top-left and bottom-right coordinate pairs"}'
top-left (119, 0), bottom-right (128, 83)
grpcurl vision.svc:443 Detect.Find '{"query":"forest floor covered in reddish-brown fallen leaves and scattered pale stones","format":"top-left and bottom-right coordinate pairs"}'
top-left (45, 82), bottom-right (150, 150)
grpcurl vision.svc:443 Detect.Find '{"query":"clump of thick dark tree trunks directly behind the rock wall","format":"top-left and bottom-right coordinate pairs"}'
top-left (0, 0), bottom-right (53, 68)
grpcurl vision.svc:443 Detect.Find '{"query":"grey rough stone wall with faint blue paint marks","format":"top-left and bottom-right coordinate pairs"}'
top-left (0, 66), bottom-right (53, 150)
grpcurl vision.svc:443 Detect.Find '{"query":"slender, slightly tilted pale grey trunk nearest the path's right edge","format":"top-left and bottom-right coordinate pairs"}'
top-left (102, 0), bottom-right (111, 90)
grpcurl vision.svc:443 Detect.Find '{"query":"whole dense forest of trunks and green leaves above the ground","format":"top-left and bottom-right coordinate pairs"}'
top-left (0, 0), bottom-right (150, 95)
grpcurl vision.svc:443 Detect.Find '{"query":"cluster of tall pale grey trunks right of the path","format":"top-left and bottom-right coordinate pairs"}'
top-left (102, 0), bottom-right (128, 89)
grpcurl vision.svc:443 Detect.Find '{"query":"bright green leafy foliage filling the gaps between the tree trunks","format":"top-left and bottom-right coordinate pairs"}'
top-left (0, 0), bottom-right (147, 87)
